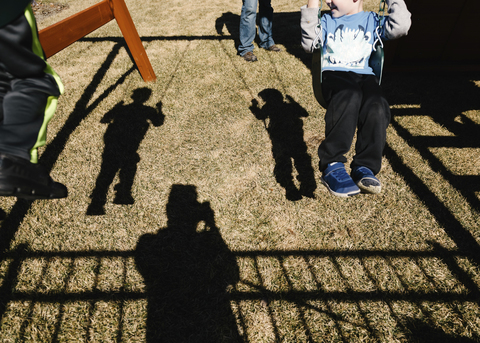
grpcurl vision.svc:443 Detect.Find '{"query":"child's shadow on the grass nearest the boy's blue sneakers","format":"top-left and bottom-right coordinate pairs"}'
top-left (250, 89), bottom-right (317, 201)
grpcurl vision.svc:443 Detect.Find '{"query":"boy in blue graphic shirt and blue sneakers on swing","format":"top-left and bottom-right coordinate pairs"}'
top-left (300, 0), bottom-right (411, 197)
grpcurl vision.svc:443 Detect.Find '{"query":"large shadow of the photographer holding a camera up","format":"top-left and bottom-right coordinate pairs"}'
top-left (135, 185), bottom-right (241, 343)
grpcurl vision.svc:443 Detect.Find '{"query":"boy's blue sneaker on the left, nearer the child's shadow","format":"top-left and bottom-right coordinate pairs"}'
top-left (322, 162), bottom-right (360, 198)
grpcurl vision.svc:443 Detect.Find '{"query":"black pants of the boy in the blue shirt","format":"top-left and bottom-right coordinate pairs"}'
top-left (318, 71), bottom-right (390, 174)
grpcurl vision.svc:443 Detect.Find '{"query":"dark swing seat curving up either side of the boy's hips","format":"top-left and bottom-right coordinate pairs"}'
top-left (312, 43), bottom-right (385, 108)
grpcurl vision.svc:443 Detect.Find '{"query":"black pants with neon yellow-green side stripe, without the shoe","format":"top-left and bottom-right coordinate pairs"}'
top-left (0, 6), bottom-right (61, 163)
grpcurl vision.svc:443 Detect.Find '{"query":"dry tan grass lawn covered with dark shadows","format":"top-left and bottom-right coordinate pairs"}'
top-left (0, 0), bottom-right (480, 343)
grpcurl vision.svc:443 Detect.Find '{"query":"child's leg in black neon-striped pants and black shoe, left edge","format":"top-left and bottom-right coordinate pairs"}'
top-left (0, 0), bottom-right (68, 200)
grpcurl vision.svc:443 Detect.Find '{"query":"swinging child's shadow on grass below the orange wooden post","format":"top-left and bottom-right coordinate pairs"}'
top-left (87, 88), bottom-right (165, 215)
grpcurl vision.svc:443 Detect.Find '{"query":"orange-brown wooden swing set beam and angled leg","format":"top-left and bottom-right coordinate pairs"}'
top-left (39, 0), bottom-right (156, 82)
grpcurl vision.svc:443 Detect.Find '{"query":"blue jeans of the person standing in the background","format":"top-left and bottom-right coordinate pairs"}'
top-left (238, 0), bottom-right (275, 56)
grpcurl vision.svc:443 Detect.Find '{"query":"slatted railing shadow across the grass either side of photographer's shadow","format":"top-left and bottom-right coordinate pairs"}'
top-left (0, 245), bottom-right (480, 342)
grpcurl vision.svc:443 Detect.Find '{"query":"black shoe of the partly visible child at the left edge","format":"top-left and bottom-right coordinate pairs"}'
top-left (0, 153), bottom-right (68, 200)
